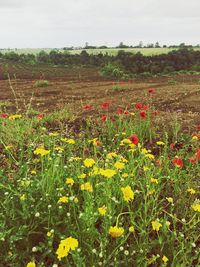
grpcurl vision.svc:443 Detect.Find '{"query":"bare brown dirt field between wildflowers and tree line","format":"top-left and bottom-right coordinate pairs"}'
top-left (0, 61), bottom-right (200, 132)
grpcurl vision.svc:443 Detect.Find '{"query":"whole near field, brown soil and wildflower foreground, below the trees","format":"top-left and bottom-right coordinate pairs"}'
top-left (0, 61), bottom-right (200, 267)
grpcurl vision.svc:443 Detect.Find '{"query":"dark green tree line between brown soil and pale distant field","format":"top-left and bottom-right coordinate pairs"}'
top-left (0, 47), bottom-right (200, 74)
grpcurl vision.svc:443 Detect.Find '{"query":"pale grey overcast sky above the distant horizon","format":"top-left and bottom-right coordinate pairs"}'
top-left (0, 0), bottom-right (200, 48)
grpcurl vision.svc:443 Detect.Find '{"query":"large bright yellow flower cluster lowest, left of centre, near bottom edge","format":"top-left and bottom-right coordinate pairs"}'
top-left (56, 236), bottom-right (78, 260)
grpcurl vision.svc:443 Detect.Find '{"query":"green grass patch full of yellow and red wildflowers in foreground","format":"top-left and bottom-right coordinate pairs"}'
top-left (0, 97), bottom-right (200, 267)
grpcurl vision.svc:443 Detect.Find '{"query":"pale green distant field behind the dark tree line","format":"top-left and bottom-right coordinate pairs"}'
top-left (0, 48), bottom-right (200, 56)
